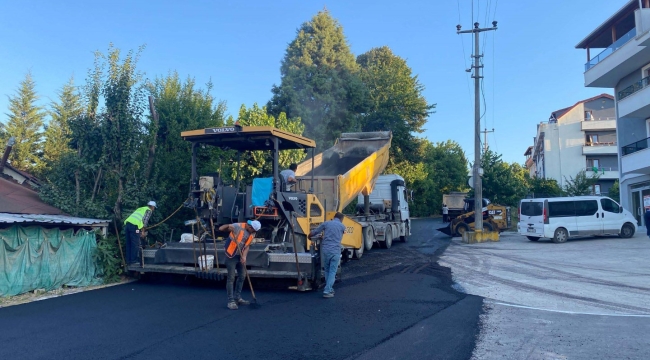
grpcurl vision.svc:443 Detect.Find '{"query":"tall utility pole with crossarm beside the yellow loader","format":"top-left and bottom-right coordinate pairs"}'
top-left (456, 21), bottom-right (497, 232)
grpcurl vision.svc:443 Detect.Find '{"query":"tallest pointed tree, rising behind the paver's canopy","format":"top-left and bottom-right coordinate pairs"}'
top-left (267, 11), bottom-right (367, 150)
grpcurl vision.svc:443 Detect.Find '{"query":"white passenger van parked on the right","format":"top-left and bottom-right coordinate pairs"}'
top-left (517, 196), bottom-right (637, 243)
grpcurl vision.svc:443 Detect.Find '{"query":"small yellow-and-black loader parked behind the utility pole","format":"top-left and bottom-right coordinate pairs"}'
top-left (438, 198), bottom-right (512, 236)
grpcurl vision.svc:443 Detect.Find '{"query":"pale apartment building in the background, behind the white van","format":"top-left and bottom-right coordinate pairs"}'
top-left (524, 94), bottom-right (619, 195)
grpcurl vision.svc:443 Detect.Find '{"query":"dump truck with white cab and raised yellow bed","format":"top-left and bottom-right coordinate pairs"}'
top-left (296, 131), bottom-right (410, 259)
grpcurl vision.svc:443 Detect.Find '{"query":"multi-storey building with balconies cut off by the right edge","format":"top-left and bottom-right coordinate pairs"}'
top-left (576, 0), bottom-right (650, 225)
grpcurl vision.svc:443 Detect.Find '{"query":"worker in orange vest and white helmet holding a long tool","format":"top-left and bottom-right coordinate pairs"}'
top-left (219, 220), bottom-right (262, 310)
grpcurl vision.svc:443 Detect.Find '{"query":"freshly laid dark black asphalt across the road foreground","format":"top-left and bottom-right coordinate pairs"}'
top-left (0, 220), bottom-right (483, 359)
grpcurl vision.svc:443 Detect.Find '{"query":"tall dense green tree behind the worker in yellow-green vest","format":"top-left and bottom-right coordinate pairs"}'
top-left (40, 44), bottom-right (148, 219)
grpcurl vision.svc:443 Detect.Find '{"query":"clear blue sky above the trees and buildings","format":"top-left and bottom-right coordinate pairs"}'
top-left (0, 0), bottom-right (627, 164)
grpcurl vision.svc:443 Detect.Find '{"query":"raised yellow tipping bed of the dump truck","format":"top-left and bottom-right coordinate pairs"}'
top-left (296, 131), bottom-right (392, 212)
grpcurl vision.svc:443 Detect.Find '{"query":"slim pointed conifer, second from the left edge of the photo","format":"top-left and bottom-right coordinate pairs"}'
top-left (43, 78), bottom-right (83, 172)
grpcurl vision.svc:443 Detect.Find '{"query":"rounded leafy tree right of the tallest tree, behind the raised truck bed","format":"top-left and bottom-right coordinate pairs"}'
top-left (357, 46), bottom-right (435, 162)
